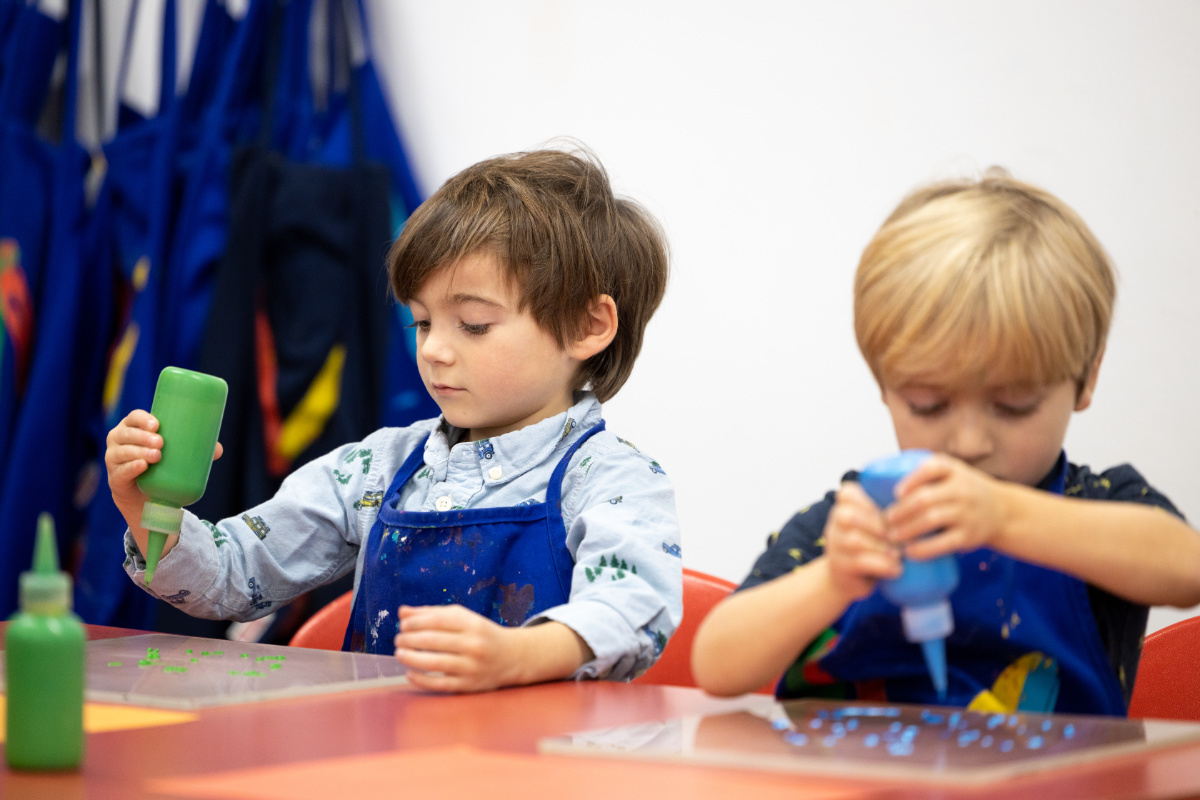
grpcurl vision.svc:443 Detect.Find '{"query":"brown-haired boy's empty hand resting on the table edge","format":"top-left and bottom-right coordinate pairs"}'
top-left (395, 606), bottom-right (529, 692)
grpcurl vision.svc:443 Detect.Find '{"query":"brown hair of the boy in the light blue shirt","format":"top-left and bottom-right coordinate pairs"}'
top-left (388, 150), bottom-right (668, 402)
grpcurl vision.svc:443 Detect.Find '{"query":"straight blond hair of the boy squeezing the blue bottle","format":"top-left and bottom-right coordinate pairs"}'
top-left (854, 168), bottom-right (1116, 391)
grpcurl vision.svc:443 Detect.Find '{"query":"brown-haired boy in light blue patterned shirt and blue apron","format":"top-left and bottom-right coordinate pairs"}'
top-left (106, 150), bottom-right (682, 691)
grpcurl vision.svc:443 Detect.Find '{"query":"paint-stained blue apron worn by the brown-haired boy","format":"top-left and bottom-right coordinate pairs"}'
top-left (342, 420), bottom-right (604, 655)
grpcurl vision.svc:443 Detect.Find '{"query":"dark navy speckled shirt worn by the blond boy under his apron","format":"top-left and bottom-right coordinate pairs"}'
top-left (738, 462), bottom-right (1183, 704)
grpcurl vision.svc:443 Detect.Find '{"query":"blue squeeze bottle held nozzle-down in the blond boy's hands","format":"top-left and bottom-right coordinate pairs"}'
top-left (858, 450), bottom-right (959, 700)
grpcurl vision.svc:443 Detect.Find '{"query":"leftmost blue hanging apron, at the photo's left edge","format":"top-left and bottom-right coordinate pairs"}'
top-left (0, 1), bottom-right (108, 619)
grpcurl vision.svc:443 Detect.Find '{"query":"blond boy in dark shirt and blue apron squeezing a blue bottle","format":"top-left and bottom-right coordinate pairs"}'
top-left (692, 170), bottom-right (1200, 715)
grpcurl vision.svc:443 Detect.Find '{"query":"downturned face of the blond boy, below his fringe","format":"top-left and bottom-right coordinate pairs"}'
top-left (883, 363), bottom-right (1099, 486)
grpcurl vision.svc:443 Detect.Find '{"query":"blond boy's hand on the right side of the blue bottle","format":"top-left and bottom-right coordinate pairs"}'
top-left (884, 455), bottom-right (1010, 560)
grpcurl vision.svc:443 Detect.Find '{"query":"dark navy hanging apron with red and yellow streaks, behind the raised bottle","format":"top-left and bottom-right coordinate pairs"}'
top-left (194, 0), bottom-right (390, 519)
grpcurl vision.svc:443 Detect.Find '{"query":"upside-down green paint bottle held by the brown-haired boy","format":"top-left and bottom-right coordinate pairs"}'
top-left (138, 367), bottom-right (229, 587)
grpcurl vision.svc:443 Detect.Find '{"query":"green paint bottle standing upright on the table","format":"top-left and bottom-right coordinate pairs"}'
top-left (4, 513), bottom-right (88, 770)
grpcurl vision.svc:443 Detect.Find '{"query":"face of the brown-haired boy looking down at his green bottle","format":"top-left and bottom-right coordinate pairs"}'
top-left (409, 253), bottom-right (580, 441)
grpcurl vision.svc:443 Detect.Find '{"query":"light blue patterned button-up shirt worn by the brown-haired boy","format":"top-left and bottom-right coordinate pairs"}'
top-left (125, 392), bottom-right (683, 680)
